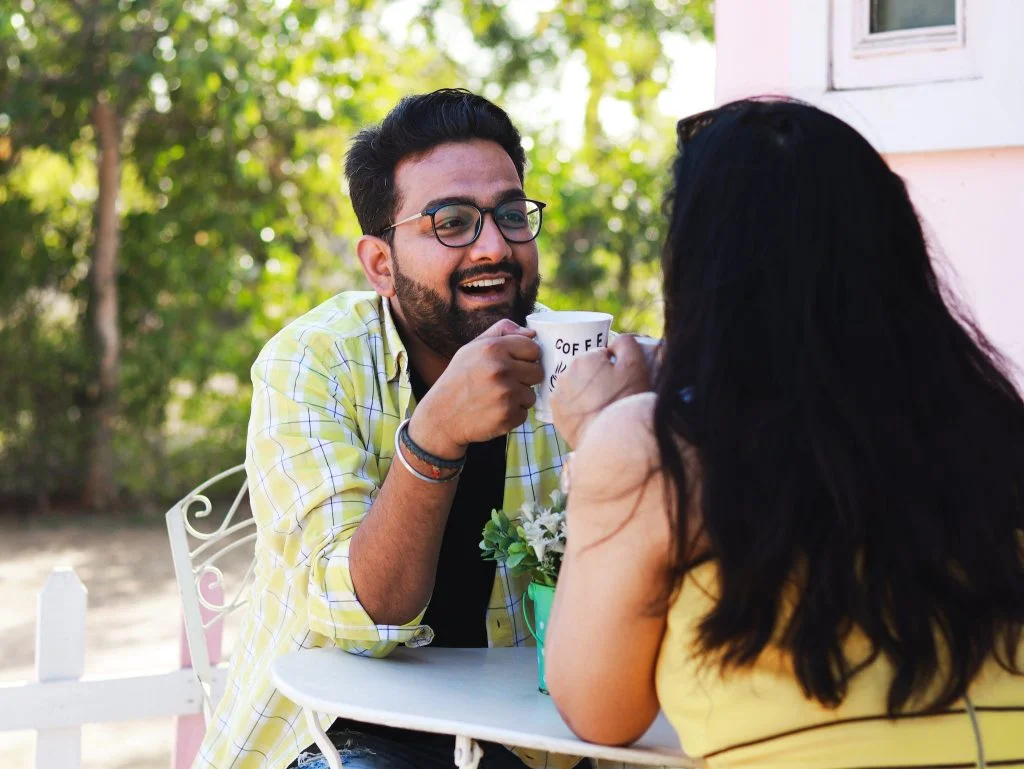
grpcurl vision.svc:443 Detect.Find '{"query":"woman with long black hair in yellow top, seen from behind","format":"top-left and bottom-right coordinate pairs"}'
top-left (546, 100), bottom-right (1024, 769)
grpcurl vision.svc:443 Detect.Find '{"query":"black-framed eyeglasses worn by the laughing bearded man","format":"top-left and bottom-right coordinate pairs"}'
top-left (380, 198), bottom-right (548, 249)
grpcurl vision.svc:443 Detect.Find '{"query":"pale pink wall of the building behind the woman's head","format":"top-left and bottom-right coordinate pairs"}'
top-left (715, 0), bottom-right (1024, 386)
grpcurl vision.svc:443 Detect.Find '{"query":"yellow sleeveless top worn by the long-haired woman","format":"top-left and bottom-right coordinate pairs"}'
top-left (656, 562), bottom-right (1024, 769)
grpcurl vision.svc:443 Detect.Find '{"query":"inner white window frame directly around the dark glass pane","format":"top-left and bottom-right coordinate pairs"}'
top-left (831, 0), bottom-right (984, 90)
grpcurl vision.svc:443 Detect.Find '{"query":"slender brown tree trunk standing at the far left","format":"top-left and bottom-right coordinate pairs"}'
top-left (83, 99), bottom-right (121, 510)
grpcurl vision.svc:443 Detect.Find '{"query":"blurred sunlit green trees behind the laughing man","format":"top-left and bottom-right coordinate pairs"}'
top-left (0, 0), bottom-right (715, 520)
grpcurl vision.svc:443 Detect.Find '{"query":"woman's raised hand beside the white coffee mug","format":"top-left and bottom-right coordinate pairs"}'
top-left (551, 335), bottom-right (650, 447)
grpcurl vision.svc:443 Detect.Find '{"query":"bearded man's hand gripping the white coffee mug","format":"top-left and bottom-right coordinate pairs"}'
top-left (409, 319), bottom-right (544, 459)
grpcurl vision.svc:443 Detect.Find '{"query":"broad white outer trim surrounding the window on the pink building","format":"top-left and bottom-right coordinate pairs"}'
top-left (787, 0), bottom-right (1024, 153)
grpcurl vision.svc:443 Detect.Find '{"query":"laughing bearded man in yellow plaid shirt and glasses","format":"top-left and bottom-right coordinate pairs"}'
top-left (197, 90), bottom-right (577, 769)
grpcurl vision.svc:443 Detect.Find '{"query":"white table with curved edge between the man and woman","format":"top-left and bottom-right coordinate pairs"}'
top-left (271, 647), bottom-right (696, 769)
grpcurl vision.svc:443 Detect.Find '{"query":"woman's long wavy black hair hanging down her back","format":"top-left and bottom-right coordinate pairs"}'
top-left (654, 99), bottom-right (1024, 714)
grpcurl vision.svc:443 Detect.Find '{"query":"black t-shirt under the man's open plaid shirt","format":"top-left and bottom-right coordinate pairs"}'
top-left (409, 368), bottom-right (508, 648)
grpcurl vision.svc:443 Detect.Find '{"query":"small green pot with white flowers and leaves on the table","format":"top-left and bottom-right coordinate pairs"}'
top-left (480, 492), bottom-right (566, 693)
